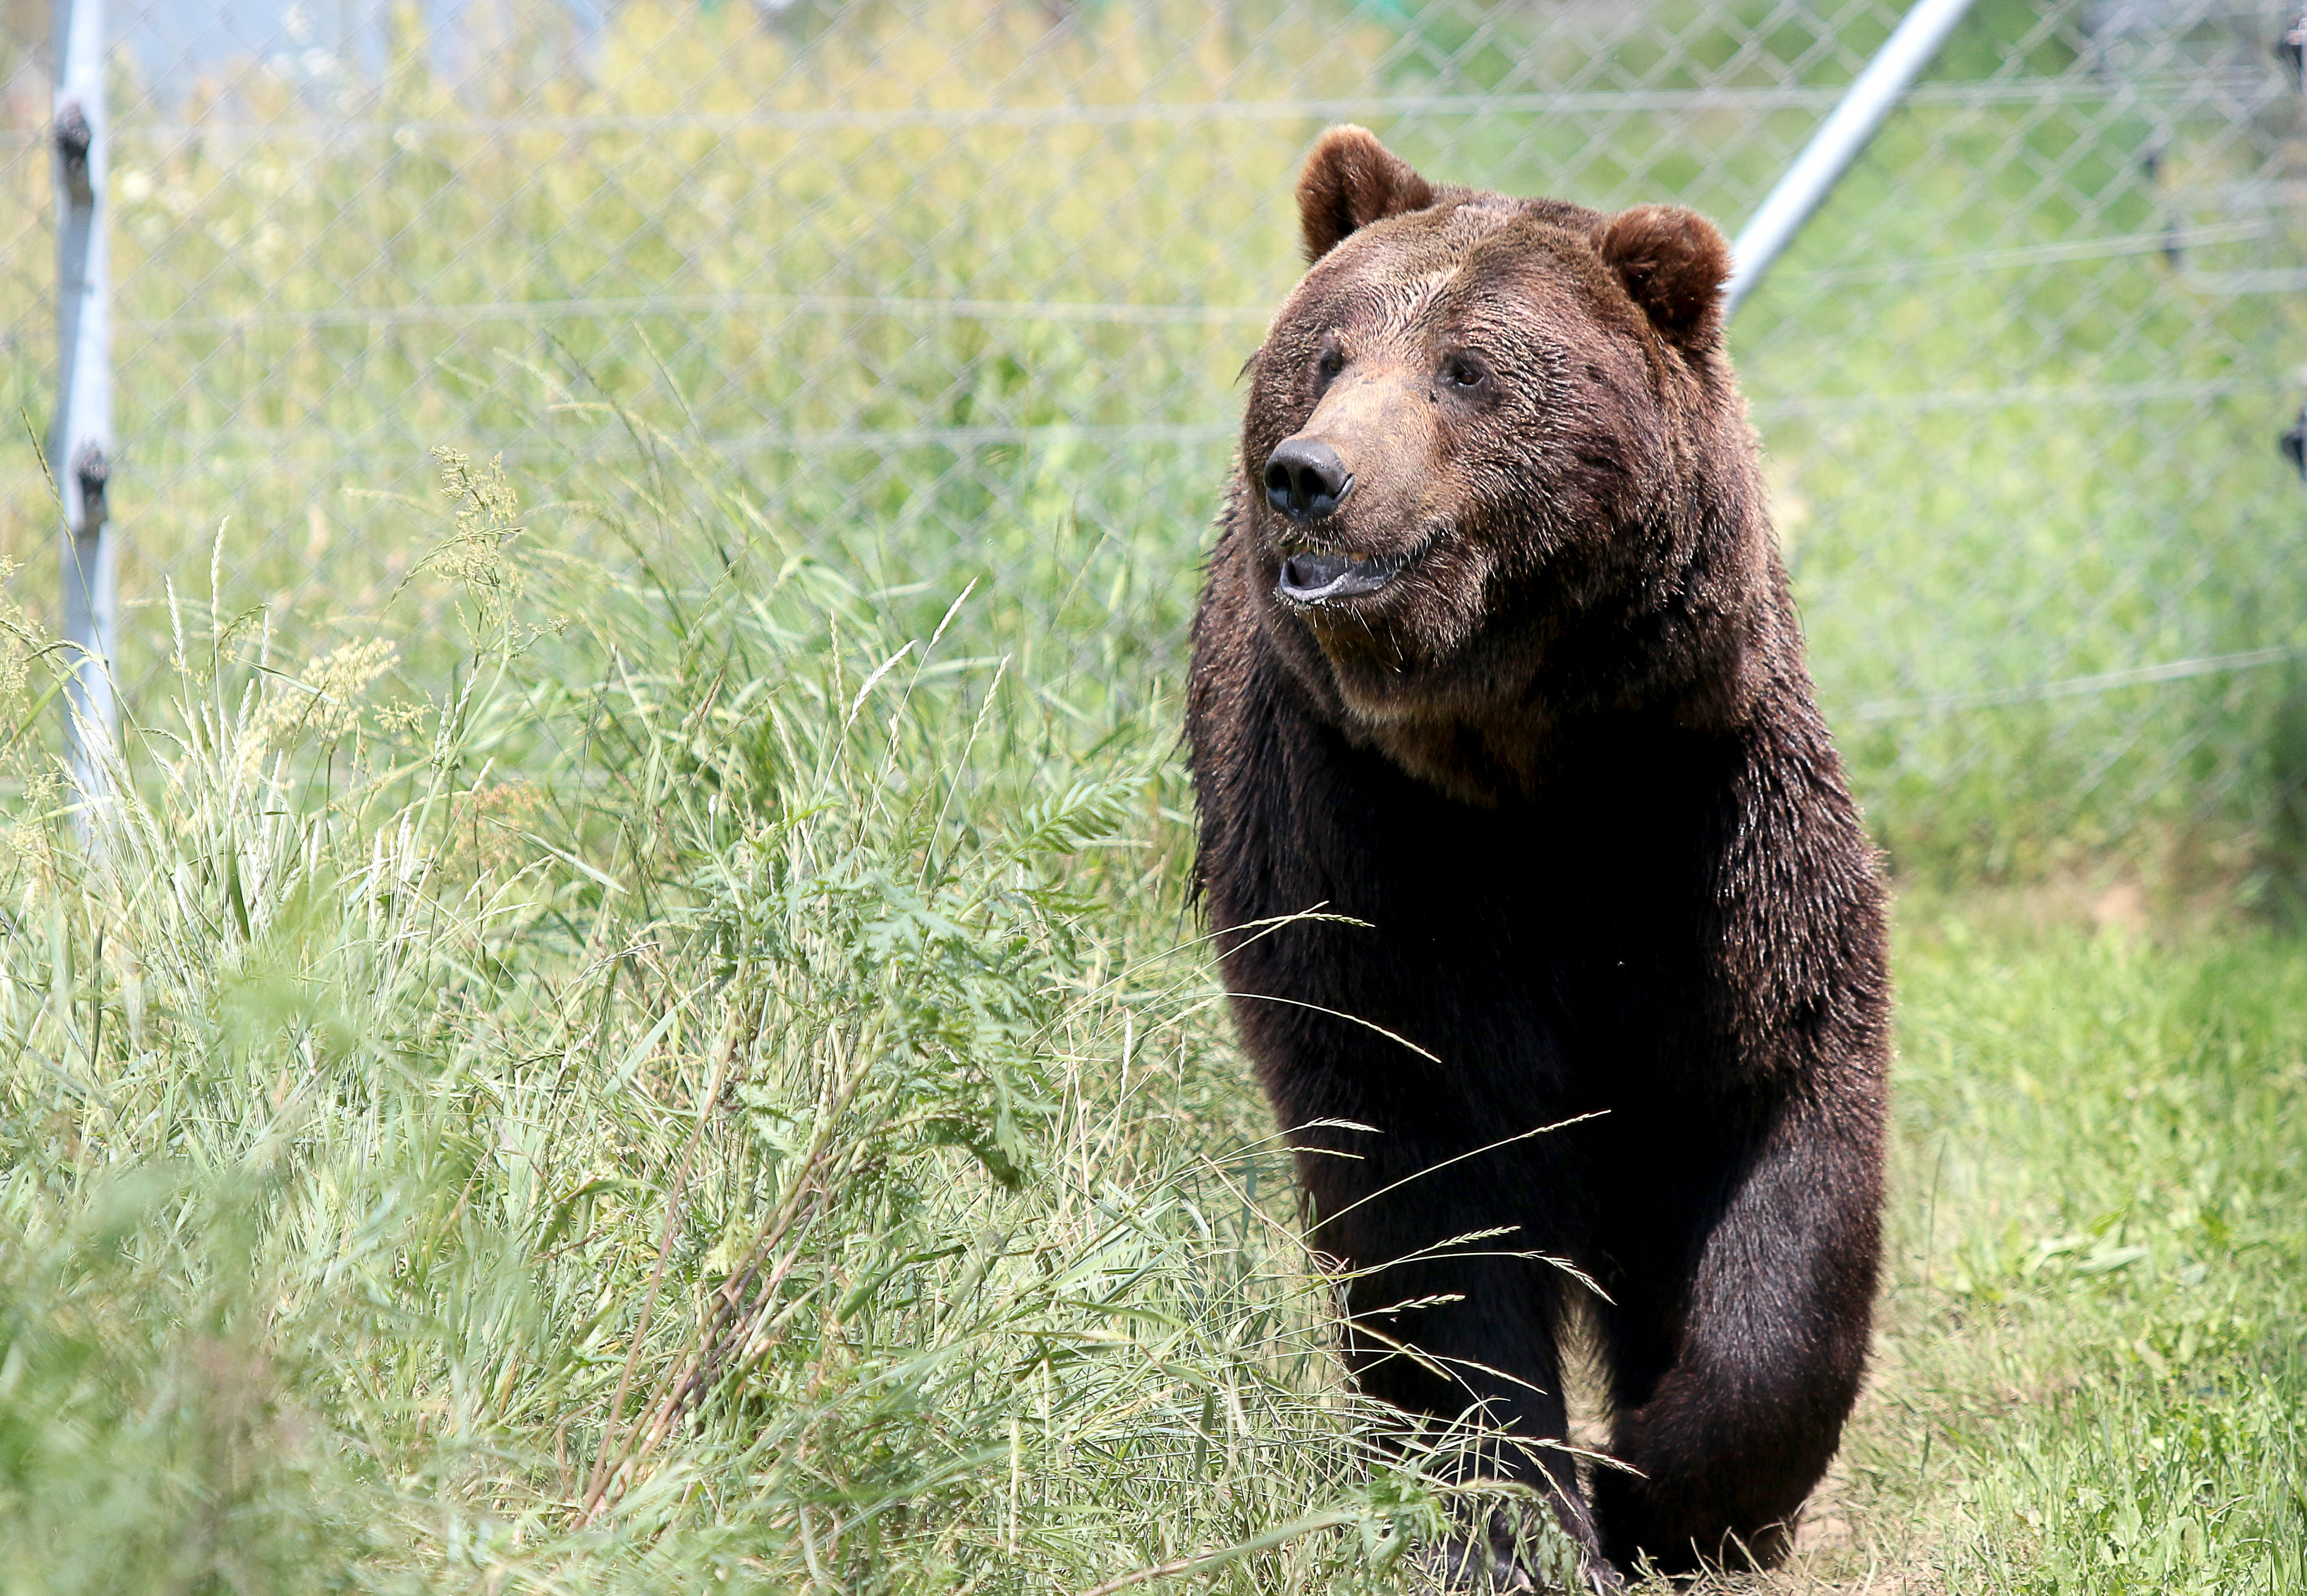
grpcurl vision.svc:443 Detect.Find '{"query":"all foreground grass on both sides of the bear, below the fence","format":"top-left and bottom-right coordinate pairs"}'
top-left (0, 464), bottom-right (2307, 1596)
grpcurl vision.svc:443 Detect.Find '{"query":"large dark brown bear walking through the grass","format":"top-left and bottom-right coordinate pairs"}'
top-left (1186, 127), bottom-right (1890, 1589)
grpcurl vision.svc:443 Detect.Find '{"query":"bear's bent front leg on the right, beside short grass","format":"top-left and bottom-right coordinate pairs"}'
top-left (1594, 1079), bottom-right (1880, 1573)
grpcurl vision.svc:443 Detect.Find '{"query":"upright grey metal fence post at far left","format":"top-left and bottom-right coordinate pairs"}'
top-left (49, 0), bottom-right (120, 812)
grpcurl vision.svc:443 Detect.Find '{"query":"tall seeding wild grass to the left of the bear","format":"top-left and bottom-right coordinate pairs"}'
top-left (0, 457), bottom-right (1568, 1591)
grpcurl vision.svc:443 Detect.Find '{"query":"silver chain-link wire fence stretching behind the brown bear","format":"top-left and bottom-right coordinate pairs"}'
top-left (0, 0), bottom-right (2307, 883)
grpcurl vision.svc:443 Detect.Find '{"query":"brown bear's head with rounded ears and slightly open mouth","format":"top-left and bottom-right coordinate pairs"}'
top-left (1237, 127), bottom-right (1781, 800)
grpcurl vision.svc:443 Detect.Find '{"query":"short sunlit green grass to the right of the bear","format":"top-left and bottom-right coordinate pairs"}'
top-left (1813, 904), bottom-right (2307, 1596)
